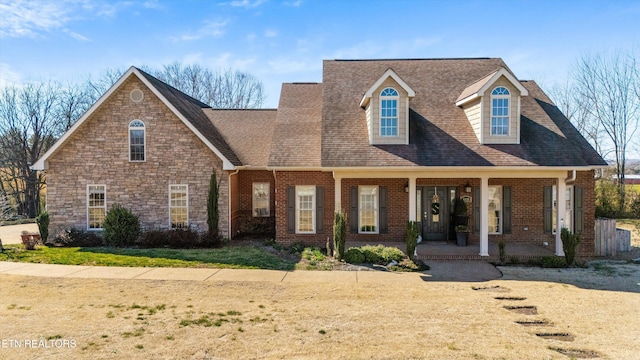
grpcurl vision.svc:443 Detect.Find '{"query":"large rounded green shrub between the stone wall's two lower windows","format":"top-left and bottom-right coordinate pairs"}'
top-left (102, 204), bottom-right (140, 246)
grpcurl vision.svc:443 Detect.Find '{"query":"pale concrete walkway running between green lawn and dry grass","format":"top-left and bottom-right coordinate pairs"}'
top-left (0, 261), bottom-right (502, 284)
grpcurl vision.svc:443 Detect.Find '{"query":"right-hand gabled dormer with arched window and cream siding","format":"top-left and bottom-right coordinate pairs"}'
top-left (456, 68), bottom-right (529, 144)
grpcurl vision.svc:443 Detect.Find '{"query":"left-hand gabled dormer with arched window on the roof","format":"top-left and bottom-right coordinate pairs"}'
top-left (360, 69), bottom-right (416, 145)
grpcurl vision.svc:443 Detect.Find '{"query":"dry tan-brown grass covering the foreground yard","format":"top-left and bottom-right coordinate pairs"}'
top-left (0, 265), bottom-right (640, 359)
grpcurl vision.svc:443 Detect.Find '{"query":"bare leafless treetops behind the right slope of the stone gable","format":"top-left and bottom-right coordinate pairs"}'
top-left (152, 62), bottom-right (265, 109)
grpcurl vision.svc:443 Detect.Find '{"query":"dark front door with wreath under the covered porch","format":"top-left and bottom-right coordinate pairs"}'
top-left (416, 186), bottom-right (457, 241)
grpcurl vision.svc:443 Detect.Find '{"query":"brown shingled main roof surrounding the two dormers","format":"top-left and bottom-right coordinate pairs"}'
top-left (322, 58), bottom-right (606, 167)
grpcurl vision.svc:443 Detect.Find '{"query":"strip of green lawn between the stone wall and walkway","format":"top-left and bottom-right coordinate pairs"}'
top-left (0, 245), bottom-right (296, 270)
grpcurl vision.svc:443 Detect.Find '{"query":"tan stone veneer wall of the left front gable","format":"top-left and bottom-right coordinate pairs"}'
top-left (47, 77), bottom-right (229, 236)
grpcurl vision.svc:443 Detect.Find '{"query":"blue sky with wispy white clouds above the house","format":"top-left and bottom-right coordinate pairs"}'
top-left (0, 0), bottom-right (640, 107)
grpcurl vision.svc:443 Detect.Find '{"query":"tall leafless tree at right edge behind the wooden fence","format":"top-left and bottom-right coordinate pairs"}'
top-left (573, 52), bottom-right (640, 211)
